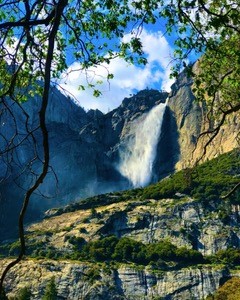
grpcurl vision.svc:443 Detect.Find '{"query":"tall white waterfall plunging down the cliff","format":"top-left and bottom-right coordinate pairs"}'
top-left (118, 102), bottom-right (167, 187)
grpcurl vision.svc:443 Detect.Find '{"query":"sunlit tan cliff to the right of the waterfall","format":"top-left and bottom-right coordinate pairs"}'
top-left (168, 72), bottom-right (240, 170)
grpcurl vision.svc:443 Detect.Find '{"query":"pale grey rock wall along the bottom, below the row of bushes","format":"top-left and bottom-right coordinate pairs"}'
top-left (0, 260), bottom-right (231, 300)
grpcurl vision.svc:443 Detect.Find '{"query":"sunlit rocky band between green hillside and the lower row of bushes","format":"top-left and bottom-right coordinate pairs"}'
top-left (28, 197), bottom-right (240, 255)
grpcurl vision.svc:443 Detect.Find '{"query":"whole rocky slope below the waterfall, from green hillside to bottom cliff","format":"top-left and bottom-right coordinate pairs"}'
top-left (0, 150), bottom-right (240, 300)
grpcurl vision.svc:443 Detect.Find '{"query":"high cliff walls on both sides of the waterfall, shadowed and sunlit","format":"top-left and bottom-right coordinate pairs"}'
top-left (0, 73), bottom-right (240, 238)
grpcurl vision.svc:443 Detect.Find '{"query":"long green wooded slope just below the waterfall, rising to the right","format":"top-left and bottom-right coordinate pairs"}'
top-left (50, 149), bottom-right (240, 217)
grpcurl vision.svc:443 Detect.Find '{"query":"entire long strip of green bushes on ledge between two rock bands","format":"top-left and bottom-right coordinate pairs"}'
top-left (22, 236), bottom-right (240, 269)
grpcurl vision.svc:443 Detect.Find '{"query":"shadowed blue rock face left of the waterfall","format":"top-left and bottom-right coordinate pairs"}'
top-left (0, 89), bottom-right (167, 238)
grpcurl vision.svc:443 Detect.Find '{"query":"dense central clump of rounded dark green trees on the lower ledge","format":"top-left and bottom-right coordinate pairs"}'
top-left (70, 236), bottom-right (204, 268)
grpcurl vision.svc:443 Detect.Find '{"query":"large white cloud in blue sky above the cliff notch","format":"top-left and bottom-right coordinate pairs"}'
top-left (60, 30), bottom-right (172, 112)
